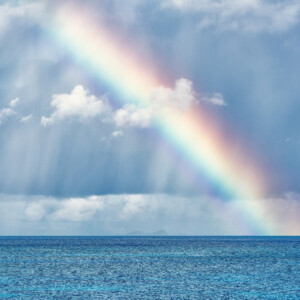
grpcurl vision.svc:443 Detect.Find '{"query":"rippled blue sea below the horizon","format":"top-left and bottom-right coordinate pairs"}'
top-left (0, 237), bottom-right (300, 299)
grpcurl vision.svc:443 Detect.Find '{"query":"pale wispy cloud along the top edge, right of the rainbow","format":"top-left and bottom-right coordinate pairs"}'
top-left (162, 0), bottom-right (300, 33)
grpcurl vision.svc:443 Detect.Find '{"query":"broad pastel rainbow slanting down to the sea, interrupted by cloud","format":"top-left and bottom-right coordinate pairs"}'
top-left (52, 5), bottom-right (298, 235)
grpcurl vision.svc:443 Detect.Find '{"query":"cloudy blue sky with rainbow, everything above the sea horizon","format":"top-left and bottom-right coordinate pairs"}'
top-left (0, 0), bottom-right (300, 235)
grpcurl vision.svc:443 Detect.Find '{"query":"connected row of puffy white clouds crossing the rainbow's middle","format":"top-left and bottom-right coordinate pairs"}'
top-left (41, 78), bottom-right (220, 130)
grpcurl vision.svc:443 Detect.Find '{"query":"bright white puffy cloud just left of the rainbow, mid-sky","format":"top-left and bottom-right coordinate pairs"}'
top-left (41, 85), bottom-right (110, 126)
